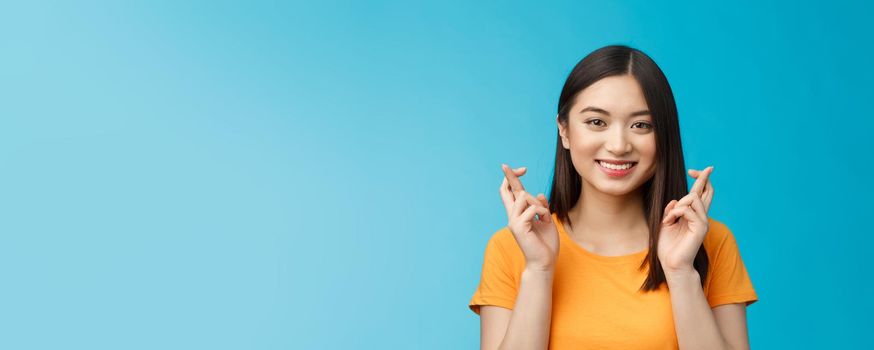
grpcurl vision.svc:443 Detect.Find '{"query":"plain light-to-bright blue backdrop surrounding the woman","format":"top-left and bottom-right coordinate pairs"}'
top-left (0, 1), bottom-right (874, 349)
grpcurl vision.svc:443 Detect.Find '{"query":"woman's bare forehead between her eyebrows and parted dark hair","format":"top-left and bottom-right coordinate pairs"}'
top-left (573, 75), bottom-right (647, 114)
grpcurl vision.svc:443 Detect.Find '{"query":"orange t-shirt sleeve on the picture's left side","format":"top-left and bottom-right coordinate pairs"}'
top-left (469, 228), bottom-right (518, 314)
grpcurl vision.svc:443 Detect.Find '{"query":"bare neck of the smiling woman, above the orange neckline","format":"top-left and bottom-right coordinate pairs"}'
top-left (568, 180), bottom-right (649, 242)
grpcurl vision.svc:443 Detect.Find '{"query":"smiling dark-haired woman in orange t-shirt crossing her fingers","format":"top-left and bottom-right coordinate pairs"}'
top-left (469, 45), bottom-right (758, 349)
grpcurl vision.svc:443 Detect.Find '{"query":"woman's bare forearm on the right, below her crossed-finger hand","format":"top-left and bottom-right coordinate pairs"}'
top-left (665, 269), bottom-right (729, 350)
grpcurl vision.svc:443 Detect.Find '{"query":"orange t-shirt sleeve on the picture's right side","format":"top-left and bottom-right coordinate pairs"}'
top-left (707, 223), bottom-right (758, 308)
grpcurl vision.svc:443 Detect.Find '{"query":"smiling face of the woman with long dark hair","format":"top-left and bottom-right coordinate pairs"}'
top-left (556, 75), bottom-right (656, 196)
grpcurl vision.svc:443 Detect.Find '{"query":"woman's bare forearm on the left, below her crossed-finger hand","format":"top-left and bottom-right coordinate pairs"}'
top-left (499, 269), bottom-right (555, 350)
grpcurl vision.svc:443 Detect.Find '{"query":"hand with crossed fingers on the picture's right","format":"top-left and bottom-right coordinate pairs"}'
top-left (658, 166), bottom-right (713, 275)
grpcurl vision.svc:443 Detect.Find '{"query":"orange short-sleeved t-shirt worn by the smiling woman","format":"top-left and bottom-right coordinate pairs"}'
top-left (469, 214), bottom-right (758, 350)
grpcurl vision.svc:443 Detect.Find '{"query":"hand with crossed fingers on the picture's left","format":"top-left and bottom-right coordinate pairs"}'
top-left (500, 164), bottom-right (559, 271)
